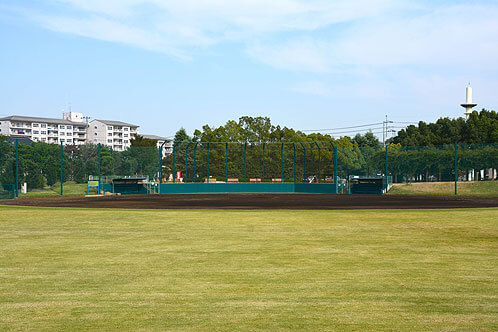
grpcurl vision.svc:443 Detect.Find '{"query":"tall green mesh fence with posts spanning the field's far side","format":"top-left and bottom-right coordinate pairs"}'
top-left (0, 138), bottom-right (498, 197)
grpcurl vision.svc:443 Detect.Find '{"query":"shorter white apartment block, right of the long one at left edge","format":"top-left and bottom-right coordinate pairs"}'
top-left (88, 120), bottom-right (139, 151)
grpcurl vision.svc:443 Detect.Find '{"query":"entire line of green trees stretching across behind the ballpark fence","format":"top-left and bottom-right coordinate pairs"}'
top-left (0, 110), bottom-right (498, 189)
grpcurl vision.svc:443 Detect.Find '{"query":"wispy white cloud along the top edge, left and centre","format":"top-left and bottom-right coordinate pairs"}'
top-left (17, 0), bottom-right (405, 58)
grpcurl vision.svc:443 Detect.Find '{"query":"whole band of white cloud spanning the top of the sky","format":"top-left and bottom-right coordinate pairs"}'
top-left (6, 0), bottom-right (498, 74)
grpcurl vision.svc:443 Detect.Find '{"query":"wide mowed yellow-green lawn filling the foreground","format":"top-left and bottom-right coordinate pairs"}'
top-left (0, 207), bottom-right (498, 331)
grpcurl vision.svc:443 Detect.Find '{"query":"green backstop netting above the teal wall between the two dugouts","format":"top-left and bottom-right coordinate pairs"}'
top-left (163, 142), bottom-right (333, 182)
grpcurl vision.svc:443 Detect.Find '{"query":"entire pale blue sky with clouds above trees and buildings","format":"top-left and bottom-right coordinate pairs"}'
top-left (0, 0), bottom-right (498, 136)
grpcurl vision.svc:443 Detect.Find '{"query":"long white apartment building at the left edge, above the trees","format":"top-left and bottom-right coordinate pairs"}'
top-left (0, 112), bottom-right (87, 145)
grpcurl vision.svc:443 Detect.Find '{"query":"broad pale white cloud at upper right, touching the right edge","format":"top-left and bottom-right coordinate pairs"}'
top-left (247, 5), bottom-right (498, 73)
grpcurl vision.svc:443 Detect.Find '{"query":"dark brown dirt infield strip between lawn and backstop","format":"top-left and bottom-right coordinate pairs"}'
top-left (0, 193), bottom-right (498, 210)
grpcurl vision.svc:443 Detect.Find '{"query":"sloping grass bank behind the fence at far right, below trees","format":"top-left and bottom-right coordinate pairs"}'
top-left (389, 181), bottom-right (498, 197)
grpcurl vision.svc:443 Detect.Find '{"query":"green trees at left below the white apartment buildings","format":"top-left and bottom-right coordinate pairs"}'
top-left (0, 136), bottom-right (159, 190)
